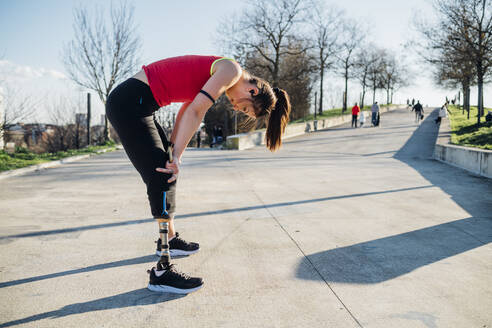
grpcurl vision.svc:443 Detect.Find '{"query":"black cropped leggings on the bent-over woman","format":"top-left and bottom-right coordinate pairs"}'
top-left (106, 78), bottom-right (176, 217)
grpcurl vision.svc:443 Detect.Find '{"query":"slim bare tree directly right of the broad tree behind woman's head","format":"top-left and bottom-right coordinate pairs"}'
top-left (311, 0), bottom-right (343, 115)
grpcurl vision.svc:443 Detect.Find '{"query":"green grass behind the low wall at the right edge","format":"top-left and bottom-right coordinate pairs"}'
top-left (449, 106), bottom-right (492, 150)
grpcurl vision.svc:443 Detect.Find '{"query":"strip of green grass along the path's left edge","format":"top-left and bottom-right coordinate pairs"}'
top-left (0, 143), bottom-right (116, 172)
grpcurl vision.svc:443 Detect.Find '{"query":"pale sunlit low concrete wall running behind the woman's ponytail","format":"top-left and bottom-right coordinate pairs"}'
top-left (226, 106), bottom-right (405, 150)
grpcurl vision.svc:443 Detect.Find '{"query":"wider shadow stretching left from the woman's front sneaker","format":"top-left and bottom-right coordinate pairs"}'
top-left (0, 288), bottom-right (186, 327)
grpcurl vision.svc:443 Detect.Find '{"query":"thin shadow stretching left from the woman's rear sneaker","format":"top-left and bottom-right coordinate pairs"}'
top-left (0, 255), bottom-right (157, 288)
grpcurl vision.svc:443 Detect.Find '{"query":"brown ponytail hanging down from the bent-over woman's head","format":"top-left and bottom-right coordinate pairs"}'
top-left (266, 88), bottom-right (290, 152)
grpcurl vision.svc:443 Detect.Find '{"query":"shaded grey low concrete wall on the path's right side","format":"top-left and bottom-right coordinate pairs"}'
top-left (434, 113), bottom-right (492, 179)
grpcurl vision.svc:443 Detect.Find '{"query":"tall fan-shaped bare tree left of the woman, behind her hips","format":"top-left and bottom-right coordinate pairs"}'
top-left (63, 2), bottom-right (141, 140)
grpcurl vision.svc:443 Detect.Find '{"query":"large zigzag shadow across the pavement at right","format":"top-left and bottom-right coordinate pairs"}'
top-left (297, 111), bottom-right (492, 284)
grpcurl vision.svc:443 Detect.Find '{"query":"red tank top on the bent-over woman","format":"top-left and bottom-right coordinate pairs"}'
top-left (142, 55), bottom-right (223, 107)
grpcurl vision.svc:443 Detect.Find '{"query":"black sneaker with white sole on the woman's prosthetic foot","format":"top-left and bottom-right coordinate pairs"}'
top-left (147, 264), bottom-right (203, 294)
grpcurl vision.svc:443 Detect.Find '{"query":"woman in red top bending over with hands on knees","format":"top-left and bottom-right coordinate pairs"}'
top-left (106, 56), bottom-right (290, 294)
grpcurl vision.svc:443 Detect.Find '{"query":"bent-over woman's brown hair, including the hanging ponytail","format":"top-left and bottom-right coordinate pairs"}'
top-left (249, 76), bottom-right (290, 152)
